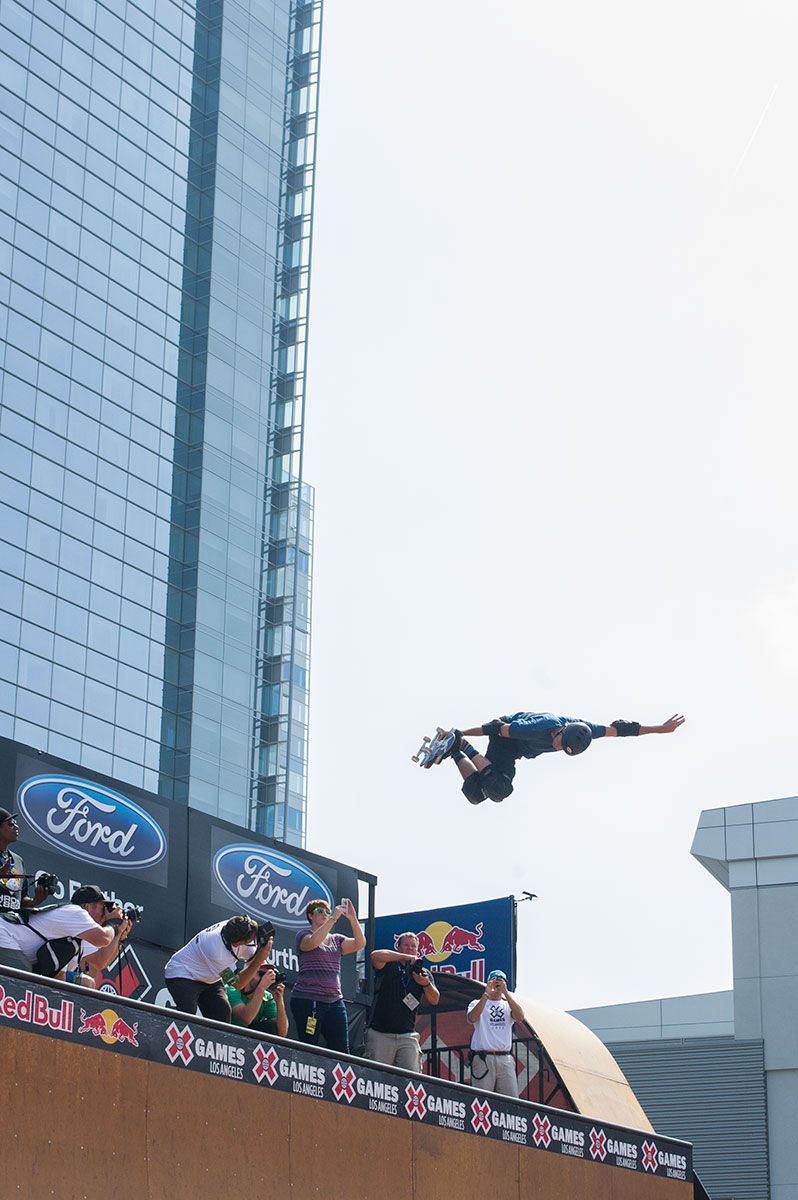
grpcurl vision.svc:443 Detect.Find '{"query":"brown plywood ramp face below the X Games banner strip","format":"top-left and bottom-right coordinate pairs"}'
top-left (0, 1027), bottom-right (692, 1200)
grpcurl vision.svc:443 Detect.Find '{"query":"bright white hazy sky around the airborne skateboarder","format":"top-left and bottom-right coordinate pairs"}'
top-left (305, 0), bottom-right (798, 1008)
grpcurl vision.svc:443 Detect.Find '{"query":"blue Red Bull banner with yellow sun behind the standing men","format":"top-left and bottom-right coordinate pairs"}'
top-left (374, 896), bottom-right (516, 990)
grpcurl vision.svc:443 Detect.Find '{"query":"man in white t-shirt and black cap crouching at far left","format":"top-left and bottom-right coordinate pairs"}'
top-left (0, 883), bottom-right (121, 974)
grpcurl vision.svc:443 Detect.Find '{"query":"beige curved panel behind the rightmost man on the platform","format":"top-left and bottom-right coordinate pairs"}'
top-left (515, 994), bottom-right (654, 1133)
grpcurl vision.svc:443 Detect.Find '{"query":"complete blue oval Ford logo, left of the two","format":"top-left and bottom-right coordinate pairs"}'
top-left (17, 775), bottom-right (167, 871)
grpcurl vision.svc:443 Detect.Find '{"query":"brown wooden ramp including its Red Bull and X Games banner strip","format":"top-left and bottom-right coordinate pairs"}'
top-left (0, 968), bottom-right (694, 1200)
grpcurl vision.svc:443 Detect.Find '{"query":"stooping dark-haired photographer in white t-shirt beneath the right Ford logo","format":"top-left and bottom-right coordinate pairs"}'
top-left (163, 916), bottom-right (275, 1021)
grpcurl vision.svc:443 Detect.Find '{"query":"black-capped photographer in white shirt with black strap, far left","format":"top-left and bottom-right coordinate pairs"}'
top-left (0, 883), bottom-right (121, 976)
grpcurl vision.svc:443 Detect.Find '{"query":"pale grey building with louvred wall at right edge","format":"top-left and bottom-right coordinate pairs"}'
top-left (574, 797), bottom-right (798, 1200)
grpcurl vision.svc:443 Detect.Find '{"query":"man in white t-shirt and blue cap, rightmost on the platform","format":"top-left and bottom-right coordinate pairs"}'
top-left (466, 971), bottom-right (523, 1098)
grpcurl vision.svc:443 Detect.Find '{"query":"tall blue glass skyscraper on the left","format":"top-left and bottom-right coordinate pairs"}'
top-left (0, 0), bottom-right (322, 845)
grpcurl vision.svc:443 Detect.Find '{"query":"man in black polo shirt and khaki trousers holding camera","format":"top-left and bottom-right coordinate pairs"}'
top-left (366, 934), bottom-right (440, 1072)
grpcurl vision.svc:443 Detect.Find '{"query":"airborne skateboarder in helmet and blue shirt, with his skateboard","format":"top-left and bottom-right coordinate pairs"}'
top-left (414, 713), bottom-right (684, 804)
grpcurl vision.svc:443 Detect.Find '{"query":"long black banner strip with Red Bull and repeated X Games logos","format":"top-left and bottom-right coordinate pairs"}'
top-left (0, 968), bottom-right (692, 1181)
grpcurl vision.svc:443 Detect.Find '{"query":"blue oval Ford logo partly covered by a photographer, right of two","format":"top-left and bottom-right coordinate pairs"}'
top-left (214, 845), bottom-right (332, 929)
